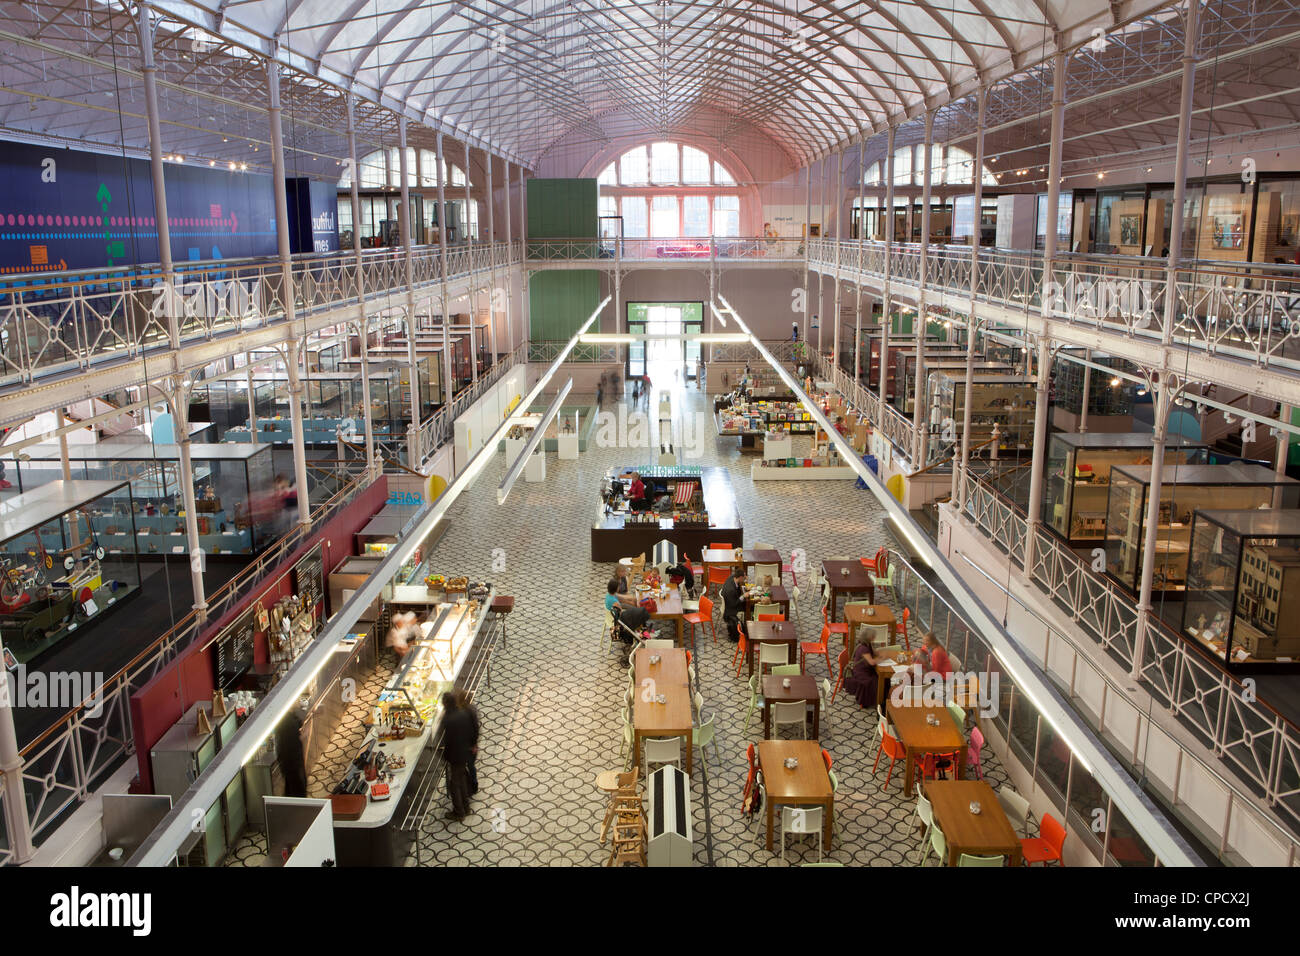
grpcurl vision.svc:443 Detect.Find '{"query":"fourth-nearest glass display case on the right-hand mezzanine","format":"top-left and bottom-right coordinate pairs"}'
top-left (928, 374), bottom-right (1037, 460)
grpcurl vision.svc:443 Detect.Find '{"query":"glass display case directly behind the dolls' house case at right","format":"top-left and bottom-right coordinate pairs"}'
top-left (1105, 463), bottom-right (1300, 596)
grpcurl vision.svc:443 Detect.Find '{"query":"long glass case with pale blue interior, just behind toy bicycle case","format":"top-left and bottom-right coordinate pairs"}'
top-left (16, 442), bottom-right (275, 554)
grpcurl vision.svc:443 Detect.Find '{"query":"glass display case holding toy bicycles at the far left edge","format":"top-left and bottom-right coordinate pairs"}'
top-left (0, 479), bottom-right (140, 674)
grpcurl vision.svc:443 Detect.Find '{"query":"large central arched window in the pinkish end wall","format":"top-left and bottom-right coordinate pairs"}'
top-left (597, 140), bottom-right (741, 238)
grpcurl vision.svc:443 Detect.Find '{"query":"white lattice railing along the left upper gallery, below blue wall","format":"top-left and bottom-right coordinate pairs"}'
top-left (0, 242), bottom-right (521, 389)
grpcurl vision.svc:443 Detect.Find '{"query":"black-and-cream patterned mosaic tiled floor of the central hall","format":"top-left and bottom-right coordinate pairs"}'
top-left (390, 366), bottom-right (1005, 866)
